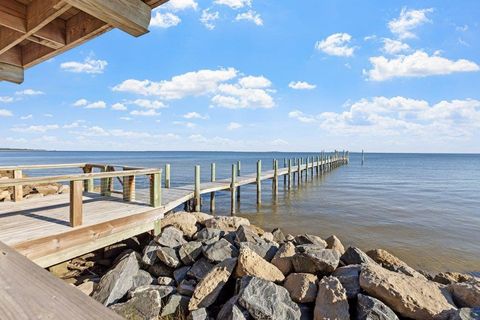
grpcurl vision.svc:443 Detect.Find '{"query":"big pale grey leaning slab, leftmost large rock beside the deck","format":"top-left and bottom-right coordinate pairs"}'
top-left (92, 251), bottom-right (140, 306)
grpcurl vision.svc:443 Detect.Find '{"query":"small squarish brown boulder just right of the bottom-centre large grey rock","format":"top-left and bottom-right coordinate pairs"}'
top-left (283, 273), bottom-right (317, 303)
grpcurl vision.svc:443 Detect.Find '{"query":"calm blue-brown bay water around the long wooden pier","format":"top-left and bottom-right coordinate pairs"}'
top-left (0, 152), bottom-right (480, 272)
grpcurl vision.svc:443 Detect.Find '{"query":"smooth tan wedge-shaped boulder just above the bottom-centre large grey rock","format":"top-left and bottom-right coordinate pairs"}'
top-left (235, 247), bottom-right (285, 282)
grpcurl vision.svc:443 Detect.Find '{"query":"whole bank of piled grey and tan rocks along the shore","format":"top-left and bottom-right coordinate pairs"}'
top-left (50, 212), bottom-right (480, 320)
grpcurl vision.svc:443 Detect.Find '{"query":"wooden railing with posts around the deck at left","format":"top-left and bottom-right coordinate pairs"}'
top-left (0, 163), bottom-right (162, 227)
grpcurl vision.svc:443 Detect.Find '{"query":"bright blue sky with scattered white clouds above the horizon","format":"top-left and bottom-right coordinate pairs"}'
top-left (0, 0), bottom-right (480, 153)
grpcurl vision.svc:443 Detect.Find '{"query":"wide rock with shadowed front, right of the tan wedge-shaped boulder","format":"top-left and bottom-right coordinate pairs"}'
top-left (292, 247), bottom-right (340, 274)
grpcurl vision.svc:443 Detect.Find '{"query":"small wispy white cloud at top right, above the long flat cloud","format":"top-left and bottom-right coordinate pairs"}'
top-left (388, 8), bottom-right (433, 39)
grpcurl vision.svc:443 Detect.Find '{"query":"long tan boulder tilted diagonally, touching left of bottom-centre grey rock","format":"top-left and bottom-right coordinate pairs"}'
top-left (188, 258), bottom-right (237, 310)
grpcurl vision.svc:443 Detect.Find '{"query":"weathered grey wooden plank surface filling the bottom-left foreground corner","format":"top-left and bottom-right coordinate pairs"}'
top-left (0, 242), bottom-right (123, 320)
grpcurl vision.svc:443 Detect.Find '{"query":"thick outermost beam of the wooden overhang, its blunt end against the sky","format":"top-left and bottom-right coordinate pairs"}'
top-left (65, 0), bottom-right (152, 37)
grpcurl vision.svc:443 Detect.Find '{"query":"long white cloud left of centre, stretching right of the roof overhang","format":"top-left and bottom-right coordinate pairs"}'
top-left (113, 68), bottom-right (237, 100)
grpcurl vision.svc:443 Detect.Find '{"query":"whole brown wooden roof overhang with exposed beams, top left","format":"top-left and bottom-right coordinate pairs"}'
top-left (0, 0), bottom-right (168, 83)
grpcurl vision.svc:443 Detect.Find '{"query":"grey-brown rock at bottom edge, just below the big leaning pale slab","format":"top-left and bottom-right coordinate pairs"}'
top-left (110, 290), bottom-right (162, 320)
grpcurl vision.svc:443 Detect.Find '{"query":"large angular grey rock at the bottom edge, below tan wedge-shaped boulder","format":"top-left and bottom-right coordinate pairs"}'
top-left (238, 277), bottom-right (301, 320)
